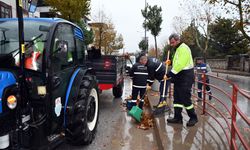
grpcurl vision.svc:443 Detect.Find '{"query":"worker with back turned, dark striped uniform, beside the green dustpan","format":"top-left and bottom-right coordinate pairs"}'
top-left (127, 63), bottom-right (148, 110)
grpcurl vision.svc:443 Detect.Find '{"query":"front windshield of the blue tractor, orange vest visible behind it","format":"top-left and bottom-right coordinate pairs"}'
top-left (0, 19), bottom-right (50, 71)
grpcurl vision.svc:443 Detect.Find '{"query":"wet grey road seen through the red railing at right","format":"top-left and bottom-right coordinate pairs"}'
top-left (206, 73), bottom-right (250, 145)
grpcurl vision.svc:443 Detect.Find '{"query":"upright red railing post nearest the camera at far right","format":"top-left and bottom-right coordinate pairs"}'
top-left (230, 84), bottom-right (238, 150)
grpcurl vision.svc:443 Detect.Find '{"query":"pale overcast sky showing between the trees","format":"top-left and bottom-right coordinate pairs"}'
top-left (91, 0), bottom-right (180, 52)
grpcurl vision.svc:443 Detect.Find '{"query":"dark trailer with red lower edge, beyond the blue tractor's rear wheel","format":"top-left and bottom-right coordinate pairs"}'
top-left (87, 49), bottom-right (125, 98)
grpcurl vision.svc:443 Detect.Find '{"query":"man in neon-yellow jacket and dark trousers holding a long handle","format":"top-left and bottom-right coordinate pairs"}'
top-left (164, 34), bottom-right (198, 126)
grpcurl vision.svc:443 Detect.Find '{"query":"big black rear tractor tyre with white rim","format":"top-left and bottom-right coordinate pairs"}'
top-left (66, 78), bottom-right (99, 145)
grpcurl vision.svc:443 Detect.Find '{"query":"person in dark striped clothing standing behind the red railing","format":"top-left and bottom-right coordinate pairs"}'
top-left (195, 58), bottom-right (212, 101)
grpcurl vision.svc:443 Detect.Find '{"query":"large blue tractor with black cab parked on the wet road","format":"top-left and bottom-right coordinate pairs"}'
top-left (0, 18), bottom-right (99, 149)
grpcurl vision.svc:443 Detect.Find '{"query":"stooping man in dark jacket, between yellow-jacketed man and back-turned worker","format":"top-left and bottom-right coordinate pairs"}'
top-left (140, 56), bottom-right (170, 115)
